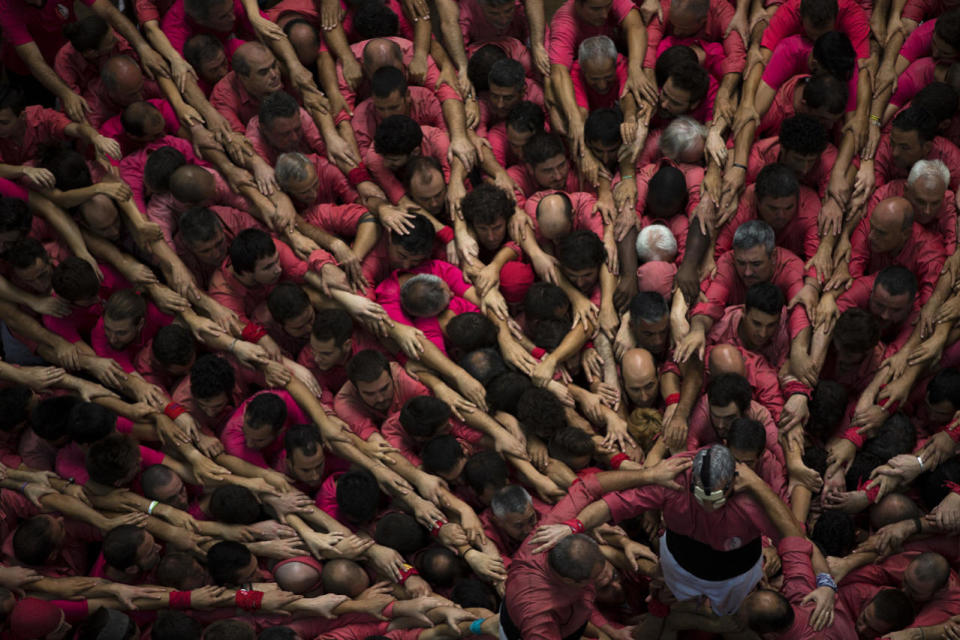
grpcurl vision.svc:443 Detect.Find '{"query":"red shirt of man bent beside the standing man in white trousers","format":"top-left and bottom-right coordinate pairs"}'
top-left (503, 475), bottom-right (614, 640)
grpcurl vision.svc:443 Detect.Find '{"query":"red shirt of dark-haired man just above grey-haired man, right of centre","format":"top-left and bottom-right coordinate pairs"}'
top-left (716, 185), bottom-right (820, 259)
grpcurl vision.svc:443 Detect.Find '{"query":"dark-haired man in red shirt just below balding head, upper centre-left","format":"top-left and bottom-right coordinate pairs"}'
top-left (350, 66), bottom-right (447, 153)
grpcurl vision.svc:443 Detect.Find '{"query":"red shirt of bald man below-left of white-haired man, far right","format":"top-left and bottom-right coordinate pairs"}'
top-left (850, 216), bottom-right (946, 305)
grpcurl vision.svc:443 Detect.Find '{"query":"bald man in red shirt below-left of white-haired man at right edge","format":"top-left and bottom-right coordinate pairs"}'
top-left (837, 198), bottom-right (946, 305)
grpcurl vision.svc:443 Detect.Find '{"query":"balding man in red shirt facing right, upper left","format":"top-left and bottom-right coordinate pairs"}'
top-left (210, 42), bottom-right (283, 133)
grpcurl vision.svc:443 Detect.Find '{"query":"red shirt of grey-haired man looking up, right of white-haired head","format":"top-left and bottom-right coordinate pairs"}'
top-left (690, 247), bottom-right (810, 338)
